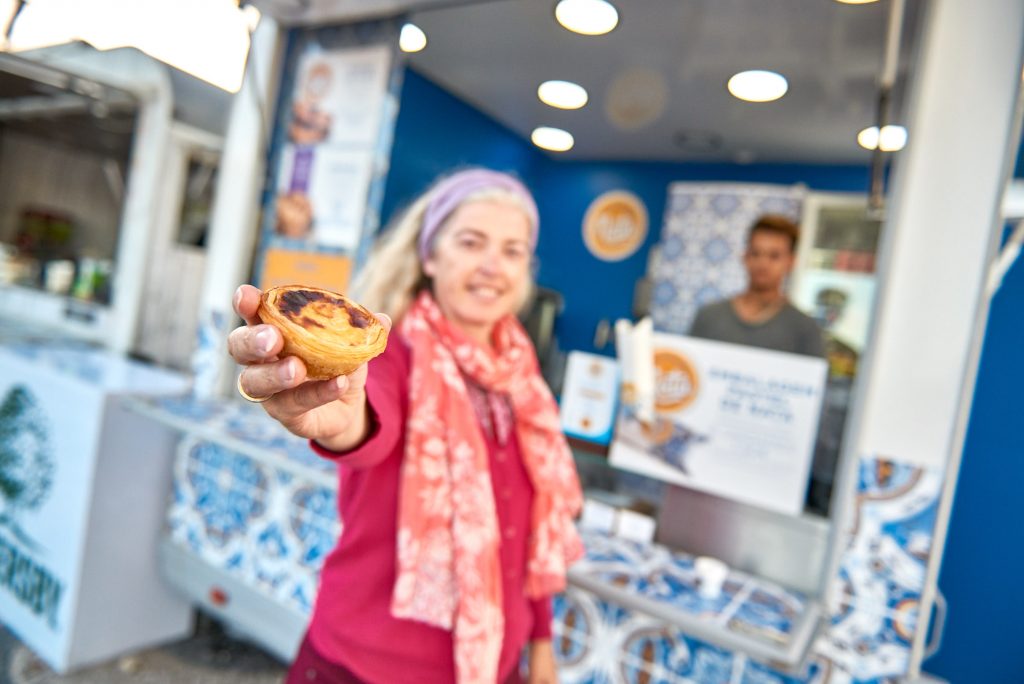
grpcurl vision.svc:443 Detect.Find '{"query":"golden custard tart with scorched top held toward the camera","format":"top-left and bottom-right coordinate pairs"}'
top-left (256, 285), bottom-right (387, 380)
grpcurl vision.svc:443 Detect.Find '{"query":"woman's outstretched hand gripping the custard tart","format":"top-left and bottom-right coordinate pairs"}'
top-left (227, 285), bottom-right (391, 452)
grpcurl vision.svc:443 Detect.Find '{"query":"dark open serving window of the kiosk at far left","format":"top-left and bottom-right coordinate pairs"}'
top-left (0, 55), bottom-right (137, 306)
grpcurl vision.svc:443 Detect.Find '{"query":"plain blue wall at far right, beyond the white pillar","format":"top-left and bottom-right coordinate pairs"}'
top-left (925, 223), bottom-right (1024, 684)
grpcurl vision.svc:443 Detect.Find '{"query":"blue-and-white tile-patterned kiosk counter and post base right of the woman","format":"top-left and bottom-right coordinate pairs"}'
top-left (555, 459), bottom-right (941, 684)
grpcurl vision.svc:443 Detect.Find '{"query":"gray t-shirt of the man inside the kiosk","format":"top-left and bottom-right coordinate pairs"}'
top-left (690, 299), bottom-right (825, 358)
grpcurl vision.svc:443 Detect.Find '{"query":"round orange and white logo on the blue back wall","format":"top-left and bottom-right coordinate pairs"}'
top-left (583, 190), bottom-right (647, 261)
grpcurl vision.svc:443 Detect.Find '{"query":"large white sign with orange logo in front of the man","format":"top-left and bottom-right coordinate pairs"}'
top-left (609, 333), bottom-right (826, 515)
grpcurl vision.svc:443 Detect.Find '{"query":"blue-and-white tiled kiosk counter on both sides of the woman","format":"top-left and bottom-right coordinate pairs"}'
top-left (143, 399), bottom-right (941, 684)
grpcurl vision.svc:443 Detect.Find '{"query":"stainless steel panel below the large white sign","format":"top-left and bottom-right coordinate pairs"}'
top-left (657, 486), bottom-right (829, 597)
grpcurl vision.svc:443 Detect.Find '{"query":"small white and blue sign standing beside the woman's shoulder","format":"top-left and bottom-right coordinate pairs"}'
top-left (560, 351), bottom-right (618, 444)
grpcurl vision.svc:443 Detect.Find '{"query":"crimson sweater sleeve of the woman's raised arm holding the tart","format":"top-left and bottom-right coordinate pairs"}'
top-left (309, 336), bottom-right (409, 469)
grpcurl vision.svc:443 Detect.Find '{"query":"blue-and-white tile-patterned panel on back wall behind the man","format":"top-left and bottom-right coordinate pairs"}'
top-left (647, 182), bottom-right (806, 335)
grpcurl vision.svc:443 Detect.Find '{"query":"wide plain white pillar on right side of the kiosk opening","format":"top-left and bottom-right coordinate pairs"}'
top-left (855, 0), bottom-right (1024, 466)
